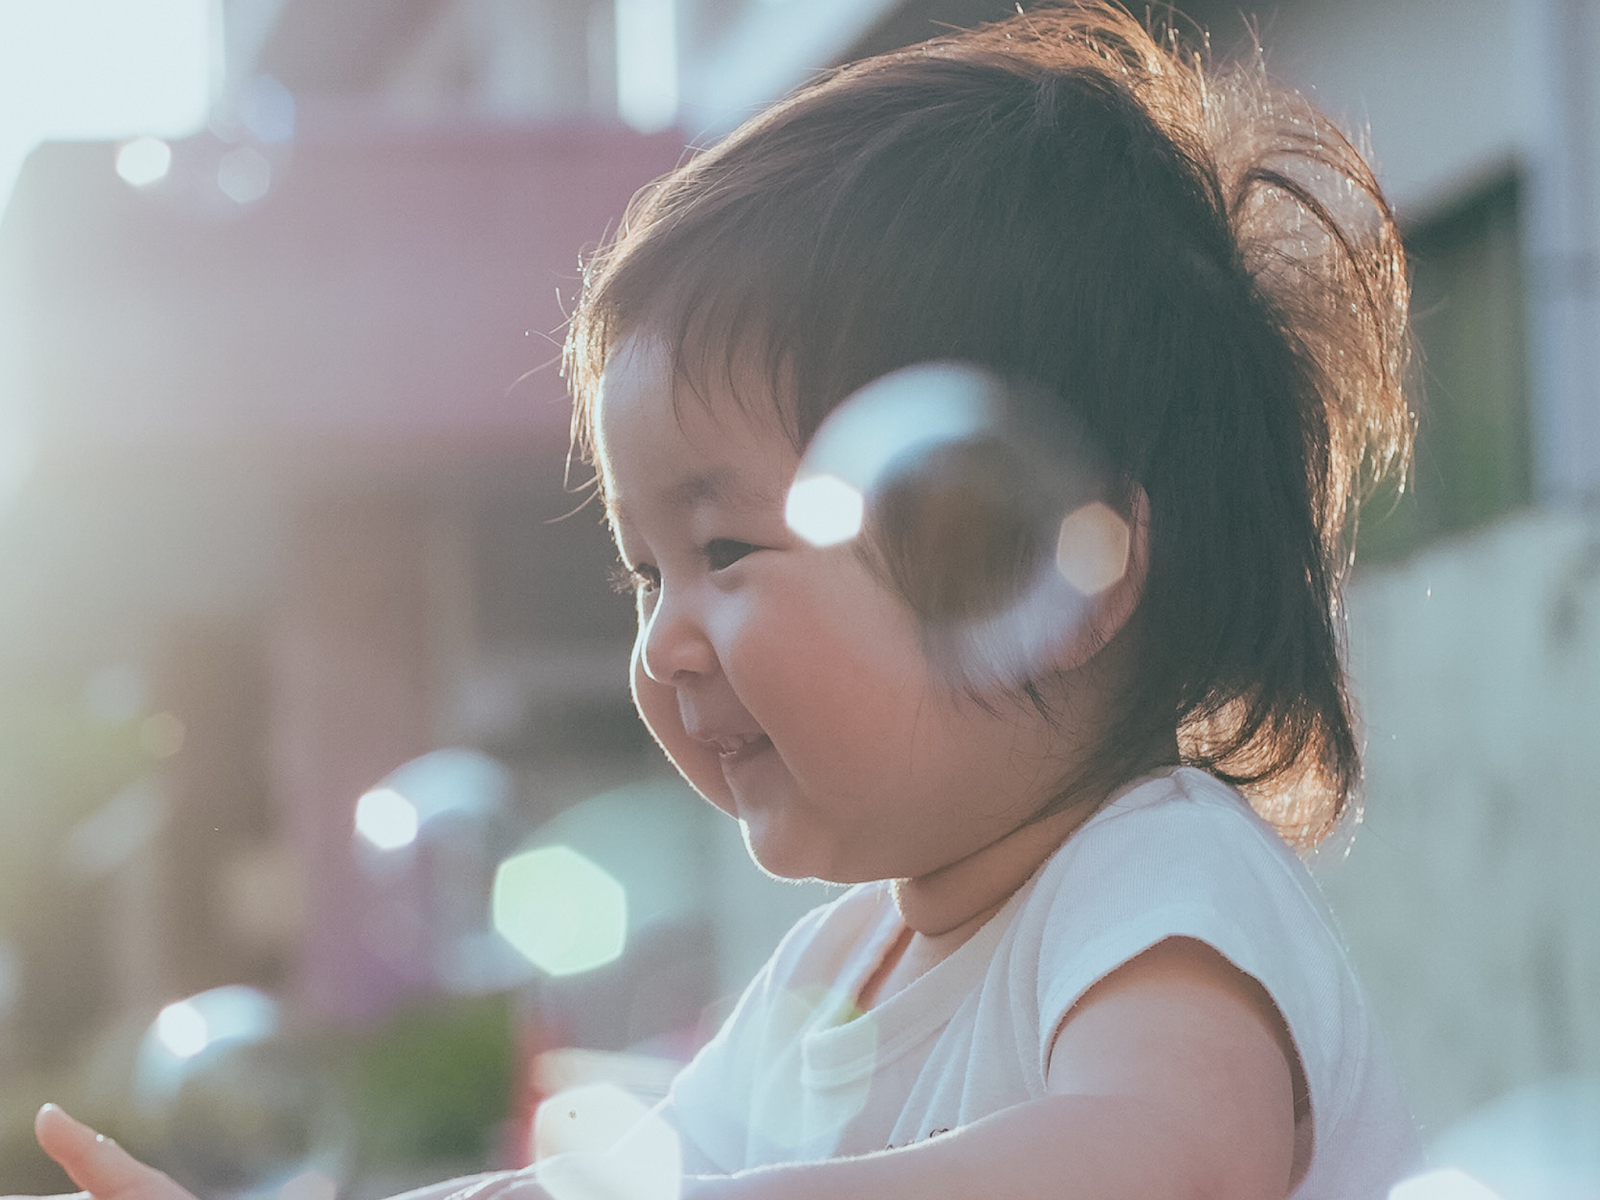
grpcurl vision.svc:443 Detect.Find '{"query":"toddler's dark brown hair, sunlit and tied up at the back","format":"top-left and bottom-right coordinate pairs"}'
top-left (566, 3), bottom-right (1411, 845)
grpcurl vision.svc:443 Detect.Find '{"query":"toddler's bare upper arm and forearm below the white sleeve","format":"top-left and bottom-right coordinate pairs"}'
top-left (685, 939), bottom-right (1294, 1200)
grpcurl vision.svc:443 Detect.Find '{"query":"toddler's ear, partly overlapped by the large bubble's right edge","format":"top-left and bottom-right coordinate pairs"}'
top-left (1056, 483), bottom-right (1150, 670)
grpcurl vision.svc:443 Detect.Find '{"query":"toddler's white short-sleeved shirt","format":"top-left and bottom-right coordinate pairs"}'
top-left (666, 768), bottom-right (1421, 1200)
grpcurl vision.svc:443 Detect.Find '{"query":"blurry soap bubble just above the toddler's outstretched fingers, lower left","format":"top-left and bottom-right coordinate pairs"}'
top-left (133, 986), bottom-right (347, 1200)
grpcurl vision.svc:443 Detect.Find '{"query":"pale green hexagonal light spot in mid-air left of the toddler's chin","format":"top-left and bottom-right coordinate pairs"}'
top-left (494, 845), bottom-right (627, 976)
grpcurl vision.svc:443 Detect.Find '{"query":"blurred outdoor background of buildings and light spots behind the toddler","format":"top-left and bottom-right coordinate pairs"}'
top-left (0, 0), bottom-right (1600, 1200)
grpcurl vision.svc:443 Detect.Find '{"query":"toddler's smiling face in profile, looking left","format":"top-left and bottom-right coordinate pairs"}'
top-left (597, 338), bottom-right (1059, 883)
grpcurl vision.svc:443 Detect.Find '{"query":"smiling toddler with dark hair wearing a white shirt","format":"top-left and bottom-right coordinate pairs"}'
top-left (18, 5), bottom-right (1416, 1200)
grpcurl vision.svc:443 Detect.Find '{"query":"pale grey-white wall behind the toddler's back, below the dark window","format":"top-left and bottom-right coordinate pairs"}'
top-left (1320, 512), bottom-right (1600, 1134)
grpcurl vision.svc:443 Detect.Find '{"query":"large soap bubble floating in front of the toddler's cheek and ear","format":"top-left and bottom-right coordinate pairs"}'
top-left (784, 362), bottom-right (1131, 690)
